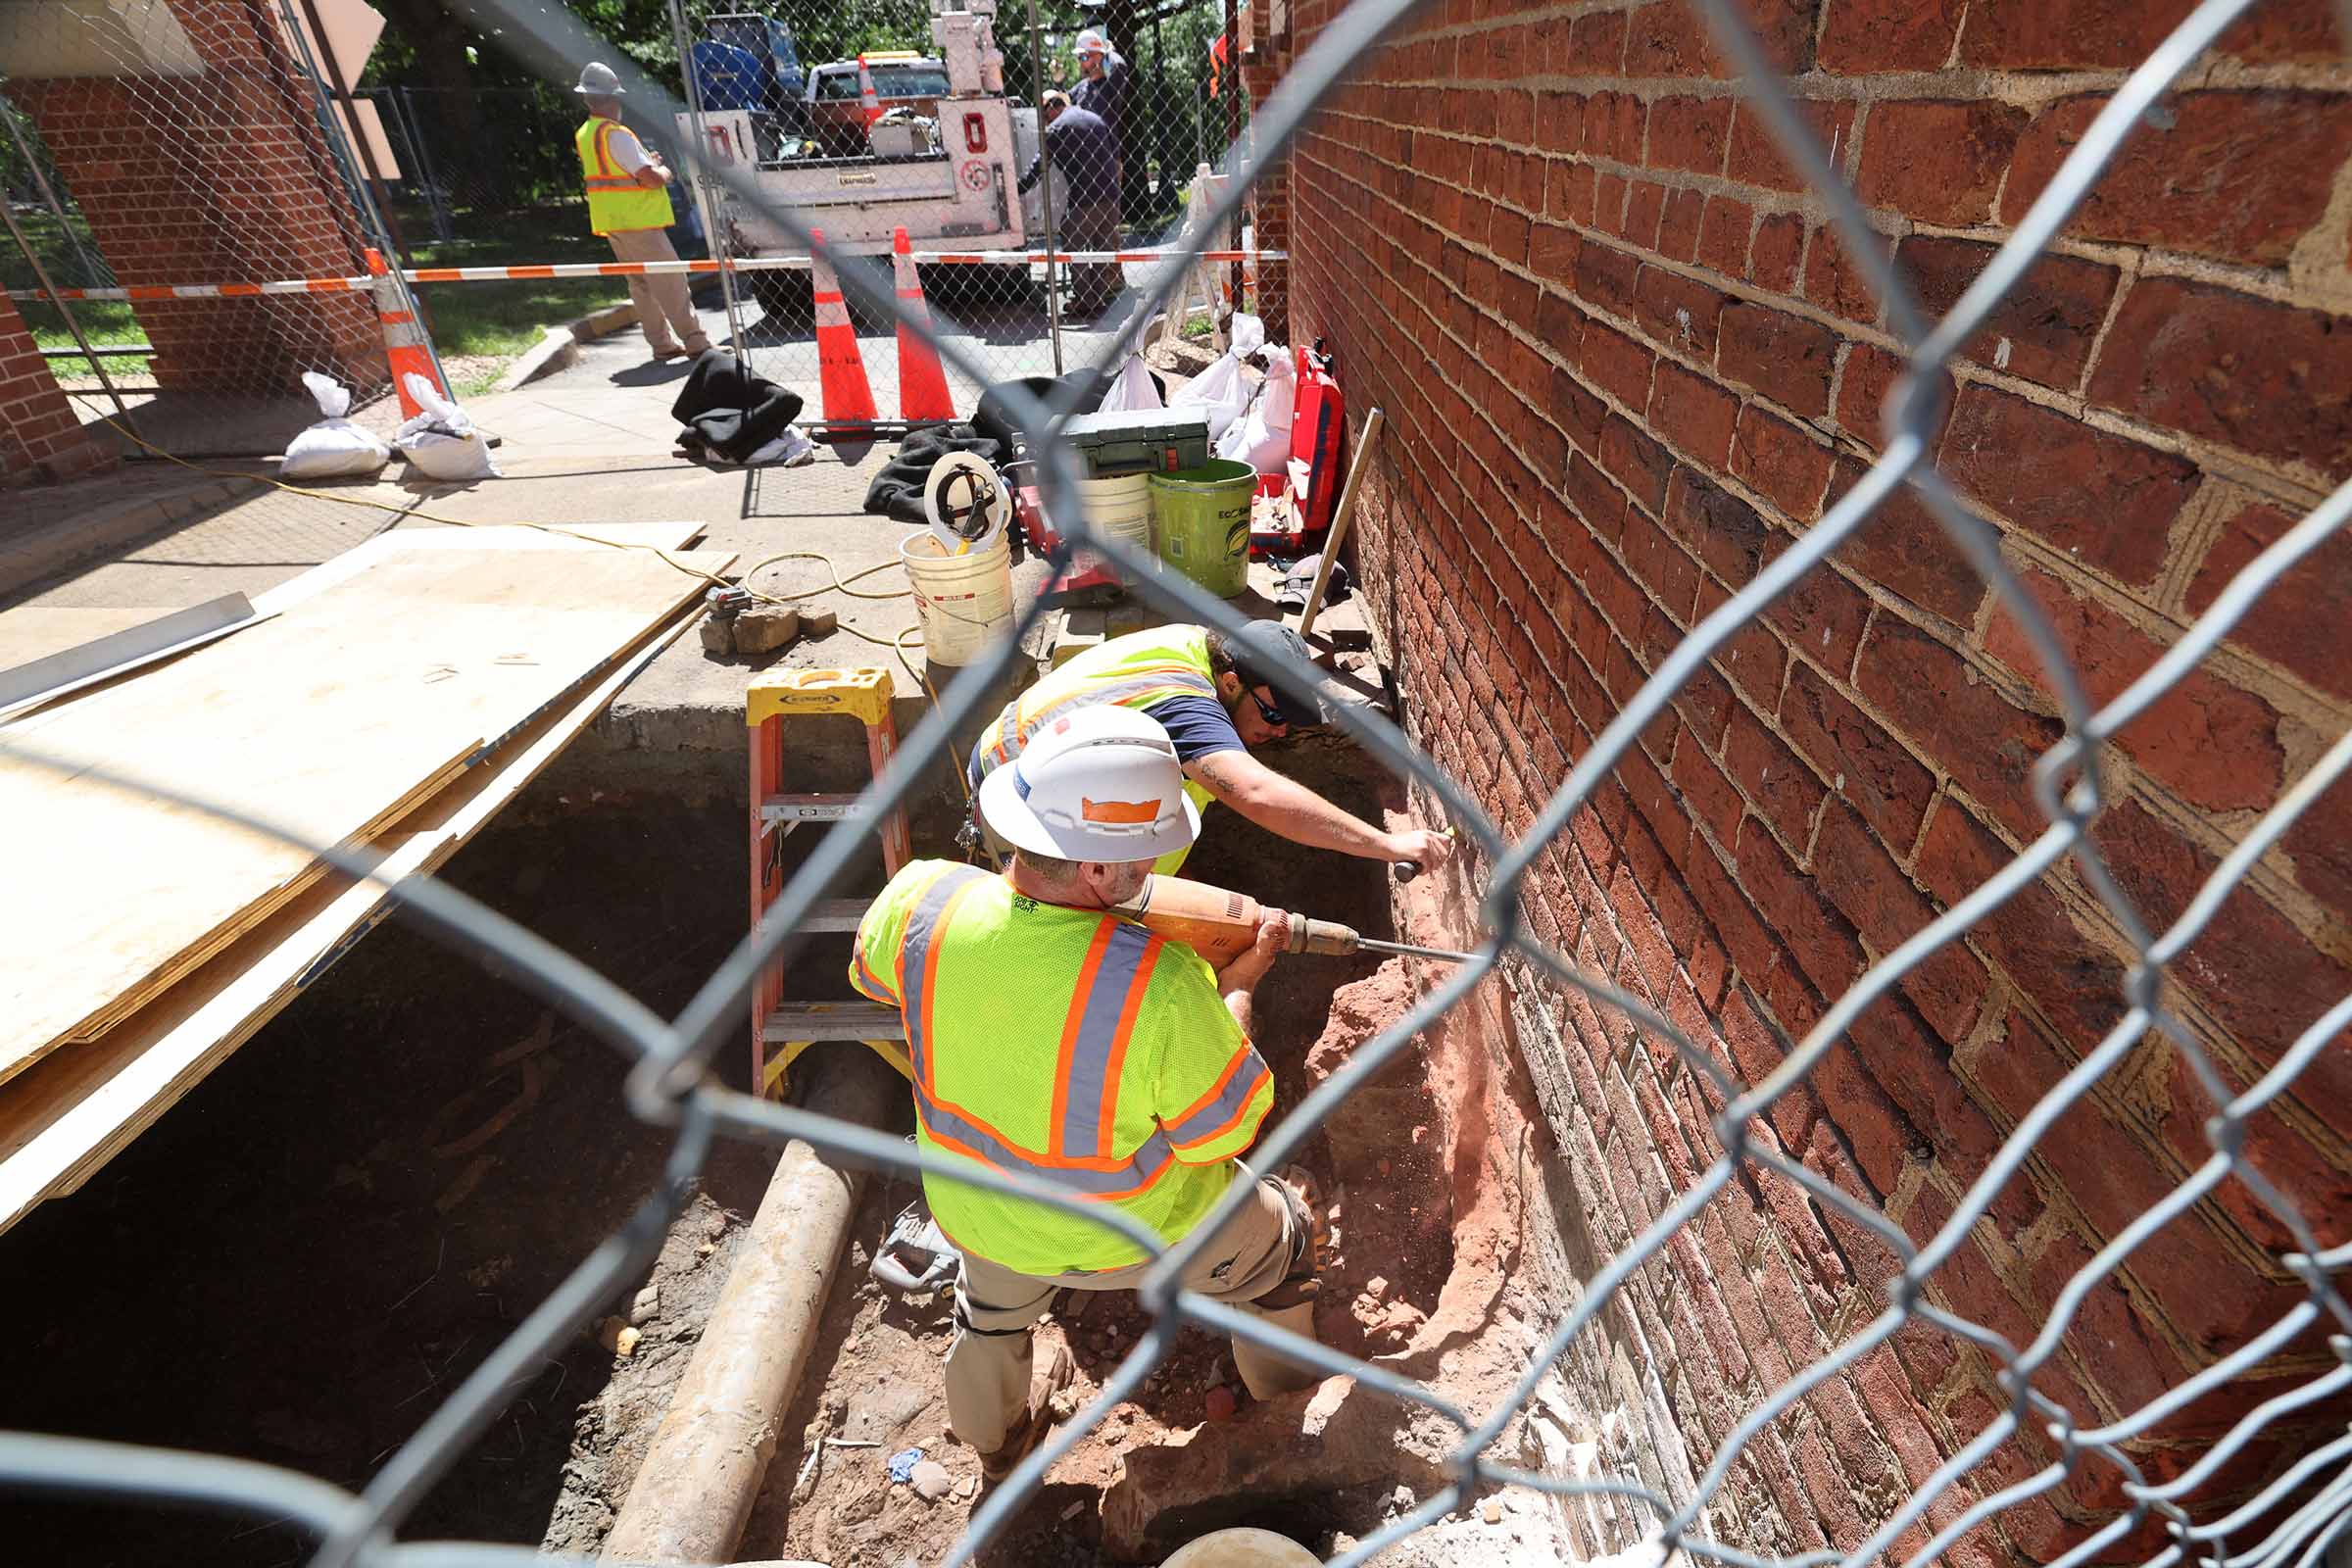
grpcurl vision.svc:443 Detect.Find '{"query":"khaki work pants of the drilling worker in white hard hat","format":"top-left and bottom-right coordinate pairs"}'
top-left (948, 1171), bottom-right (1322, 1452)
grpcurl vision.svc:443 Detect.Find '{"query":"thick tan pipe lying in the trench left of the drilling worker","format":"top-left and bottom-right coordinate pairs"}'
top-left (605, 1049), bottom-right (896, 1563)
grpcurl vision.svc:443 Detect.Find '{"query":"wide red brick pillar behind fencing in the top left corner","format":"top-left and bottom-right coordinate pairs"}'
top-left (10, 0), bottom-right (386, 395)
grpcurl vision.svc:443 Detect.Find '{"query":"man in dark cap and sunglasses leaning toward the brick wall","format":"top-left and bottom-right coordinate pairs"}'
top-left (964, 620), bottom-right (1453, 872)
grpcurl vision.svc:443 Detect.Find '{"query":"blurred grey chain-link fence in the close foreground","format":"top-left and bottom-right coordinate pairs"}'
top-left (0, 0), bottom-right (2352, 1568)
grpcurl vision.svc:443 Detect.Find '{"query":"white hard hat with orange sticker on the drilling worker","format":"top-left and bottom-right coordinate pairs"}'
top-left (981, 703), bottom-right (1200, 862)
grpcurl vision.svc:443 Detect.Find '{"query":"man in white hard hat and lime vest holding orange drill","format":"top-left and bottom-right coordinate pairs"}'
top-left (849, 708), bottom-right (1315, 1481)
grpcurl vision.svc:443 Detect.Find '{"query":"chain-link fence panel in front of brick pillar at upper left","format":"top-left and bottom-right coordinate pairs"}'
top-left (0, 2), bottom-right (414, 456)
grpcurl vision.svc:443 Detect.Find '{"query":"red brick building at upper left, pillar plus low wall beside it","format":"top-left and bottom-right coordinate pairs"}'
top-left (0, 0), bottom-right (386, 477)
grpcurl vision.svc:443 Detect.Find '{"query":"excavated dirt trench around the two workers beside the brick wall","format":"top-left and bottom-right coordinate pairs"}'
top-left (0, 743), bottom-right (1505, 1568)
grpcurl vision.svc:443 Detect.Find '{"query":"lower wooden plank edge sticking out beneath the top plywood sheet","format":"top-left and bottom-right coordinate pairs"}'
top-left (0, 618), bottom-right (692, 1230)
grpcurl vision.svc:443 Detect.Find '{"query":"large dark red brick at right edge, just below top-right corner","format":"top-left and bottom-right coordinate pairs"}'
top-left (2001, 92), bottom-right (2352, 266)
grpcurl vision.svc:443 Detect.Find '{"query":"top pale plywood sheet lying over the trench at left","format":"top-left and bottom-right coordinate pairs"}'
top-left (0, 548), bottom-right (734, 1081)
